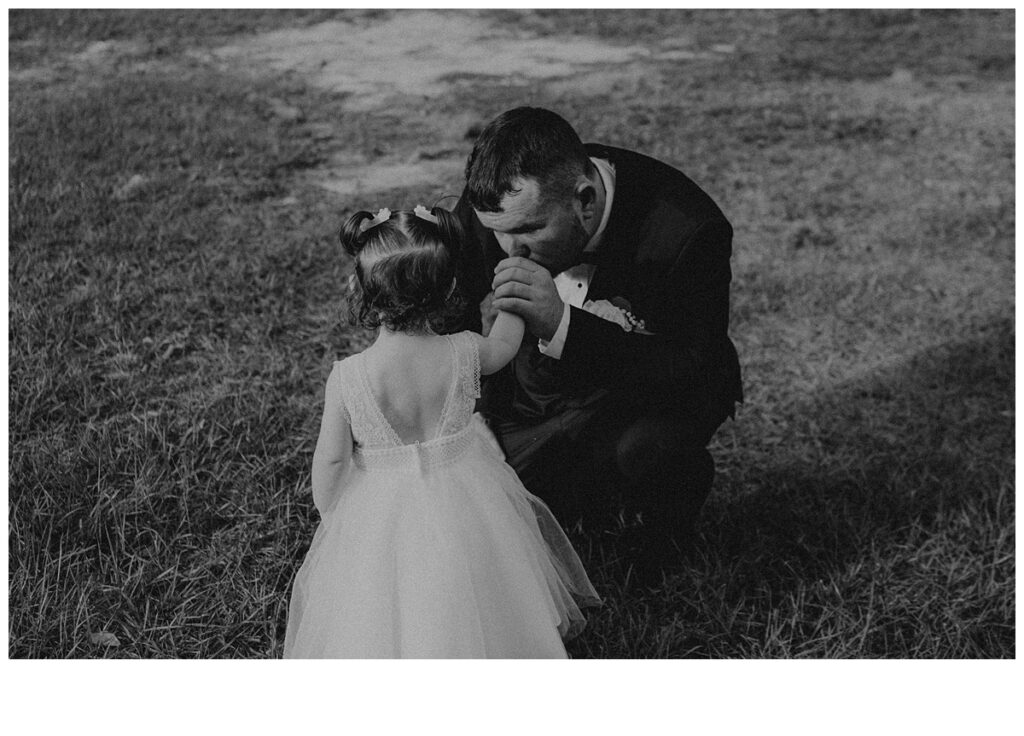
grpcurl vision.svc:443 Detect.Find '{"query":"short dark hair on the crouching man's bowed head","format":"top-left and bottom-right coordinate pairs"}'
top-left (466, 107), bottom-right (590, 212)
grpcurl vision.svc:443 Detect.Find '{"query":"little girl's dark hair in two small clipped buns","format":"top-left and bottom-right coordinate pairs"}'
top-left (340, 207), bottom-right (463, 333)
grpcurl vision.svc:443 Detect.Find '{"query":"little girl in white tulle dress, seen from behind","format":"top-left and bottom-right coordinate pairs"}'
top-left (285, 207), bottom-right (600, 658)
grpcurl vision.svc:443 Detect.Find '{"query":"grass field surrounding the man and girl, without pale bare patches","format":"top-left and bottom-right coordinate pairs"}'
top-left (8, 10), bottom-right (1015, 658)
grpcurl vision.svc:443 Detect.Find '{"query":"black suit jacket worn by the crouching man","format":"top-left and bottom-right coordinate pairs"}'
top-left (455, 143), bottom-right (742, 437)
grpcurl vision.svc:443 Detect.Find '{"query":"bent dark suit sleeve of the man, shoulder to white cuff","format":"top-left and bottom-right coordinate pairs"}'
top-left (561, 219), bottom-right (732, 408)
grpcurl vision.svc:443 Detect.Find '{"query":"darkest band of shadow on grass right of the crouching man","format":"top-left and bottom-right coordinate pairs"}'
top-left (703, 313), bottom-right (1014, 571)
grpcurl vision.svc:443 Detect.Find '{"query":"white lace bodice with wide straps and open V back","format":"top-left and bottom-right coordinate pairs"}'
top-left (336, 332), bottom-right (480, 465)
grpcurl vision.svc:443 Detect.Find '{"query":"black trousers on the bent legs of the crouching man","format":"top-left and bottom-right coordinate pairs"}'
top-left (486, 390), bottom-right (729, 544)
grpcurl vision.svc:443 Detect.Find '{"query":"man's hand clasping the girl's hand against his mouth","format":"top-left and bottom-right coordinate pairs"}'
top-left (490, 257), bottom-right (565, 340)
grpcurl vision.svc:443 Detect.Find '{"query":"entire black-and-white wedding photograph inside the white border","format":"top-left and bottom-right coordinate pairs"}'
top-left (6, 7), bottom-right (1016, 712)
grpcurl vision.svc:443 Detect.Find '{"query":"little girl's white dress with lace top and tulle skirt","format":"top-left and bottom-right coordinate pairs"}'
top-left (285, 333), bottom-right (600, 658)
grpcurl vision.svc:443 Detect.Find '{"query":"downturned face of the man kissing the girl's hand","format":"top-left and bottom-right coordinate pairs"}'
top-left (475, 179), bottom-right (588, 275)
